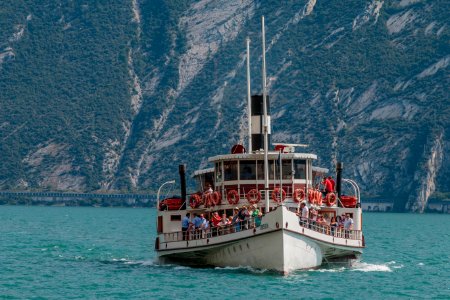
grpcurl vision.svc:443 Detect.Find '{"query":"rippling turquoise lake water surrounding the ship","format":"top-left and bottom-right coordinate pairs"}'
top-left (0, 206), bottom-right (450, 299)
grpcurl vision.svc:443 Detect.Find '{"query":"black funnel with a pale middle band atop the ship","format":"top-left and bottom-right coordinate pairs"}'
top-left (251, 95), bottom-right (271, 151)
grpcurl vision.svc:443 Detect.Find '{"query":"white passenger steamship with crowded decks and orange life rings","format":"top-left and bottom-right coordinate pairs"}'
top-left (155, 17), bottom-right (365, 274)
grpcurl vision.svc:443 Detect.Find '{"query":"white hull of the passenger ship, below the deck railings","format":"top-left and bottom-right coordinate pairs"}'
top-left (158, 207), bottom-right (363, 274)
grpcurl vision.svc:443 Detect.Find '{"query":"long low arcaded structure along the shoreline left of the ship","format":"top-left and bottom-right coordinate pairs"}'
top-left (0, 191), bottom-right (156, 206)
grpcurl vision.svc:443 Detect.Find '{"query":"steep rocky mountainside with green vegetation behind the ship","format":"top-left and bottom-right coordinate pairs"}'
top-left (0, 0), bottom-right (450, 212)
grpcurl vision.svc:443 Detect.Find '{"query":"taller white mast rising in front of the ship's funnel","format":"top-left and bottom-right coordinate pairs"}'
top-left (261, 16), bottom-right (270, 213)
